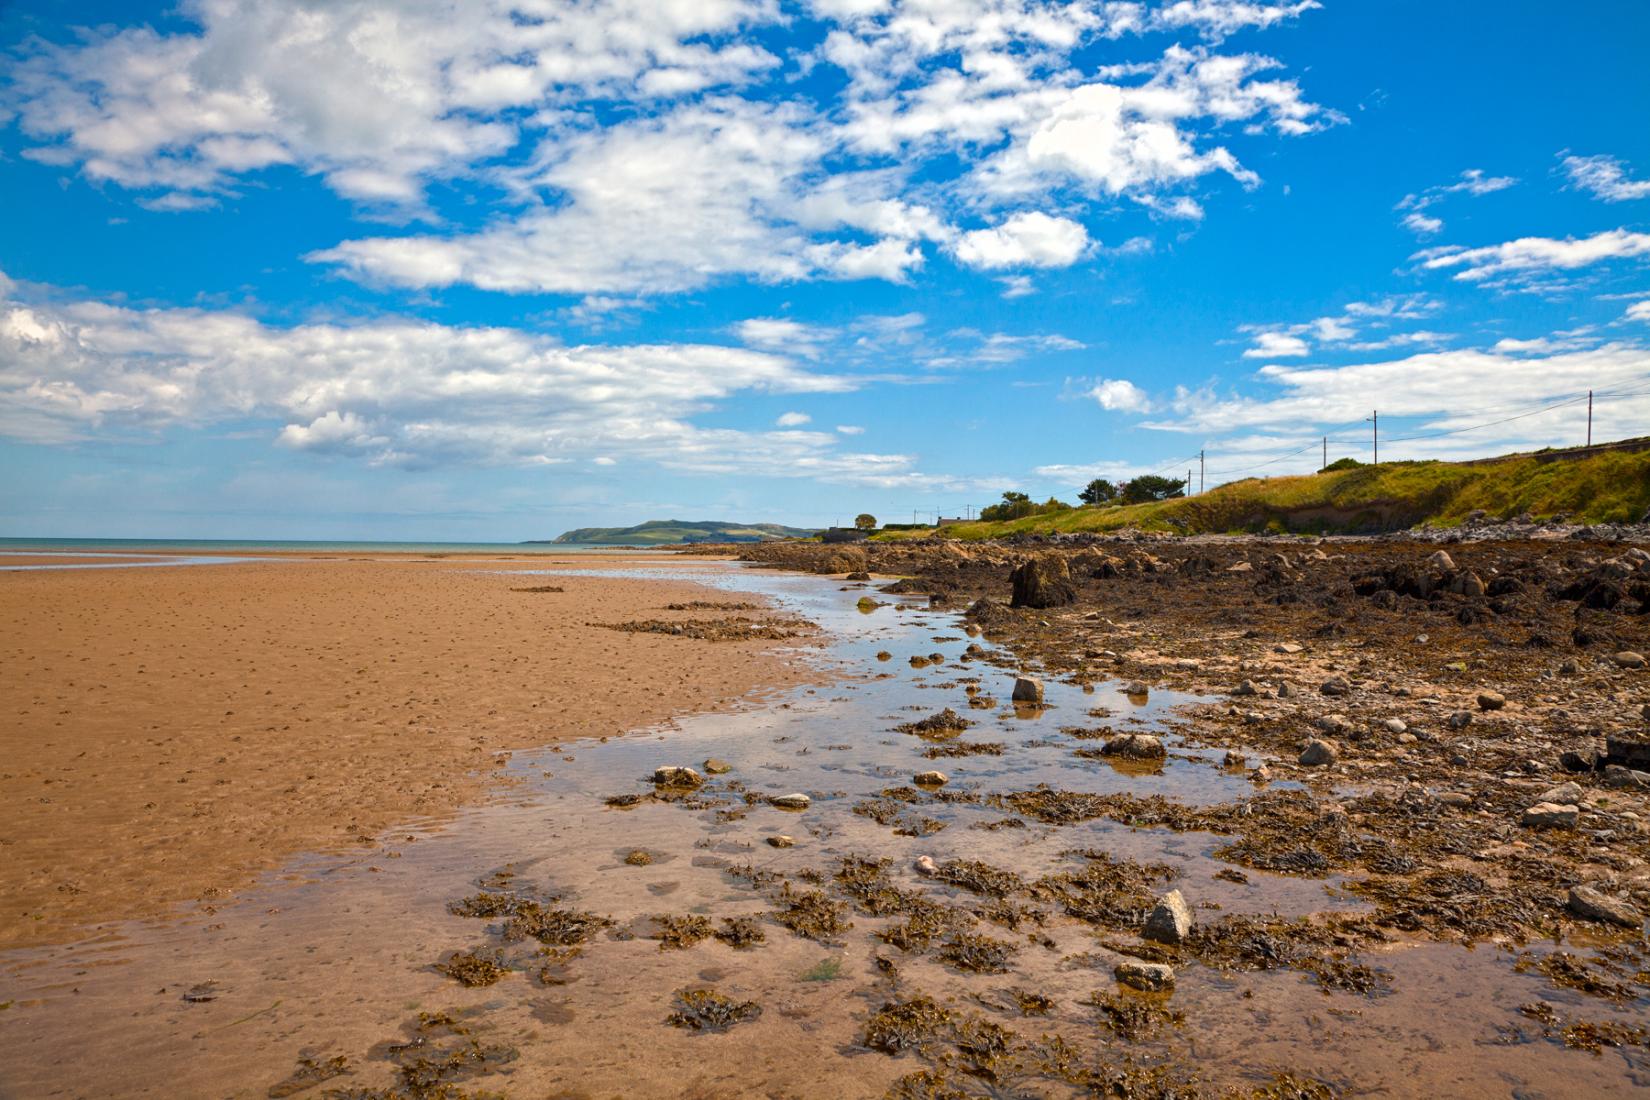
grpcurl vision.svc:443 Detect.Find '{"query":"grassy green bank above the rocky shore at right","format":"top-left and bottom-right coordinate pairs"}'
top-left (888, 441), bottom-right (1650, 539)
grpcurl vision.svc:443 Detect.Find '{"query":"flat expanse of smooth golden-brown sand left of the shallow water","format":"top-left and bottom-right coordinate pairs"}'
top-left (0, 554), bottom-right (805, 947)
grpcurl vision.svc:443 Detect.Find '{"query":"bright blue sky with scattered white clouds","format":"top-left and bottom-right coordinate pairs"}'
top-left (0, 0), bottom-right (1650, 541)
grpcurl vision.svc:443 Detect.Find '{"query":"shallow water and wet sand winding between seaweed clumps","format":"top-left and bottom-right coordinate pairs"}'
top-left (0, 562), bottom-right (1650, 1097)
